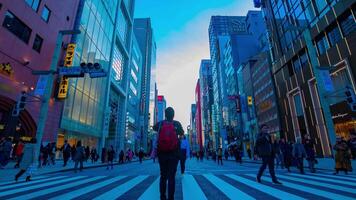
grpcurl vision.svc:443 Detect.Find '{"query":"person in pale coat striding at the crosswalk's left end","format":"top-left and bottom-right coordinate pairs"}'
top-left (15, 138), bottom-right (37, 182)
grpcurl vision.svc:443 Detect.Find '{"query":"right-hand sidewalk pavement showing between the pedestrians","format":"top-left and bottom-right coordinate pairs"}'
top-left (236, 157), bottom-right (356, 175)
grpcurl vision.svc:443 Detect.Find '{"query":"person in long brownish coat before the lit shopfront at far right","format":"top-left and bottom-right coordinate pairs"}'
top-left (334, 136), bottom-right (352, 175)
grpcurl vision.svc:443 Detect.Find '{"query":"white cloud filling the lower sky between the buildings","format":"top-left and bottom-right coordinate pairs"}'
top-left (157, 0), bottom-right (253, 128)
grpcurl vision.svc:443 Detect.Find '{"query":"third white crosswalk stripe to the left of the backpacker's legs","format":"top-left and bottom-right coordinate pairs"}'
top-left (51, 176), bottom-right (126, 200)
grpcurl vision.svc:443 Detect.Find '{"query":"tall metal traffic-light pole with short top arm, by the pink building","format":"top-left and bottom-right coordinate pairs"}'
top-left (35, 30), bottom-right (80, 164)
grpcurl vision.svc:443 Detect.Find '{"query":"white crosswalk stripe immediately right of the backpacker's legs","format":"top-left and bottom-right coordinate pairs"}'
top-left (182, 175), bottom-right (207, 200)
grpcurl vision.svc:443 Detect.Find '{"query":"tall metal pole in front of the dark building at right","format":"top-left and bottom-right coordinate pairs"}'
top-left (303, 28), bottom-right (336, 156)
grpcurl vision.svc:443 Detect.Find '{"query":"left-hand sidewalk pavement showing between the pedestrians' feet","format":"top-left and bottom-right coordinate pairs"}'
top-left (0, 159), bottom-right (142, 183)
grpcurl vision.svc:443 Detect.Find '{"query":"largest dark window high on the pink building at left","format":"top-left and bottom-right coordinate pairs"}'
top-left (2, 11), bottom-right (32, 44)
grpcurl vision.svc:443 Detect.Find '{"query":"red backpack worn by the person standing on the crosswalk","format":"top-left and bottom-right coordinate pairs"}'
top-left (157, 121), bottom-right (178, 152)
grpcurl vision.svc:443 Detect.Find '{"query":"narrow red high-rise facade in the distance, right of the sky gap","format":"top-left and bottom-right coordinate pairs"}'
top-left (195, 79), bottom-right (204, 150)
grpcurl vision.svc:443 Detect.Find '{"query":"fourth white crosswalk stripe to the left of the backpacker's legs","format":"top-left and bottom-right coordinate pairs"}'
top-left (10, 176), bottom-right (106, 200)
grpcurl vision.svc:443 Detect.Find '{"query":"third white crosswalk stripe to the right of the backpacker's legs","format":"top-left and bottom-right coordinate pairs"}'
top-left (225, 174), bottom-right (304, 200)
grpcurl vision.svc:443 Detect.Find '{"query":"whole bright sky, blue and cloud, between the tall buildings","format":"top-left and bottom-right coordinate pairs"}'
top-left (135, 0), bottom-right (254, 127)
